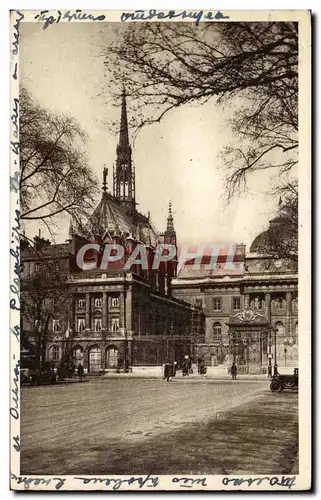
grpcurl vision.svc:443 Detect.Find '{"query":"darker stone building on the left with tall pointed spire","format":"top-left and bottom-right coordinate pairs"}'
top-left (21, 91), bottom-right (205, 373)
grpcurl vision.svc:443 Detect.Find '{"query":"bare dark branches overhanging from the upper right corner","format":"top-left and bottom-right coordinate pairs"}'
top-left (105, 22), bottom-right (298, 198)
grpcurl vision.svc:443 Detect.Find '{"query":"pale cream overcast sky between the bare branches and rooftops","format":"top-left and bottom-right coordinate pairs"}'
top-left (20, 23), bottom-right (277, 247)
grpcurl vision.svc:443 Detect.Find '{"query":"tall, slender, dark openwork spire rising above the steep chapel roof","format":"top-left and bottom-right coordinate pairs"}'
top-left (113, 89), bottom-right (136, 215)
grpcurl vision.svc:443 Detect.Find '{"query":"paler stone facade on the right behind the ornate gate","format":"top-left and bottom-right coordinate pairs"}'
top-left (172, 229), bottom-right (298, 373)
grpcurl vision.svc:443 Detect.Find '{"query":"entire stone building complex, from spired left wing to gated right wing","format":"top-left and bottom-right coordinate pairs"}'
top-left (21, 95), bottom-right (298, 373)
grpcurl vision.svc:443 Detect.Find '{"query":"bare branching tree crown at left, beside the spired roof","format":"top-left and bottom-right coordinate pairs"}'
top-left (20, 87), bottom-right (97, 229)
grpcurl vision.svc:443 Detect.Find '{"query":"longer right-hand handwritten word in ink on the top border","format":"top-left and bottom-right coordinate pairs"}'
top-left (120, 9), bottom-right (230, 26)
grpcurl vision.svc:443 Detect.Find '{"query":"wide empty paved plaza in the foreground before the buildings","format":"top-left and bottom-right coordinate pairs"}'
top-left (21, 378), bottom-right (298, 474)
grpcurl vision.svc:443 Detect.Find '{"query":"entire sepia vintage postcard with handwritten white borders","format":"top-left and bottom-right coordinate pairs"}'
top-left (10, 9), bottom-right (311, 492)
